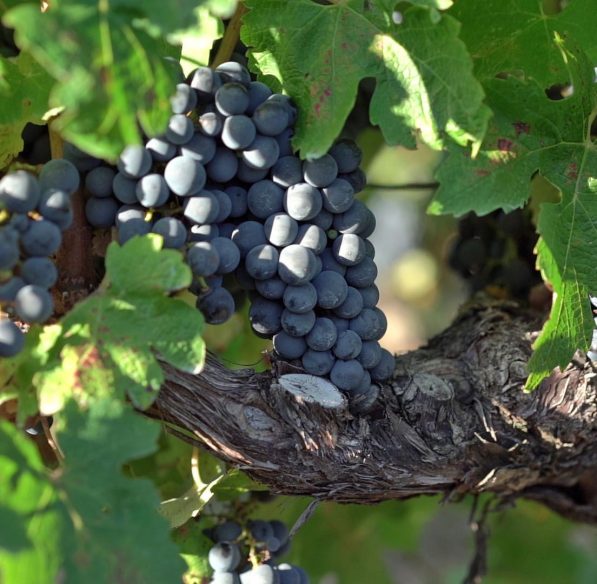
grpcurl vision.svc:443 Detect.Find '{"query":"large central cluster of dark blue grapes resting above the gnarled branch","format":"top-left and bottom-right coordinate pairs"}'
top-left (74, 62), bottom-right (394, 400)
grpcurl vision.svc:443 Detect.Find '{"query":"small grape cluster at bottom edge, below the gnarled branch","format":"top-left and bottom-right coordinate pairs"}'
top-left (207, 520), bottom-right (309, 584)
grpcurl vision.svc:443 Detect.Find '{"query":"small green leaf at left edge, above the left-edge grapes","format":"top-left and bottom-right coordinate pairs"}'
top-left (0, 52), bottom-right (53, 168)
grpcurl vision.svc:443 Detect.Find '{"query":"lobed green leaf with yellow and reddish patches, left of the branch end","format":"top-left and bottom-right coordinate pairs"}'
top-left (33, 235), bottom-right (205, 414)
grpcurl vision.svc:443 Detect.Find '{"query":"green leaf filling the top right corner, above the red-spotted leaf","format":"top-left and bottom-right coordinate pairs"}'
top-left (450, 0), bottom-right (597, 88)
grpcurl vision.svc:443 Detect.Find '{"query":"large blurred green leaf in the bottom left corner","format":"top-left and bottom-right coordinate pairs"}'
top-left (0, 399), bottom-right (184, 584)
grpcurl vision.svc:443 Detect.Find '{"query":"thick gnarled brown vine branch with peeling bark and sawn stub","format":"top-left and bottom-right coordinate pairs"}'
top-left (152, 301), bottom-right (597, 523)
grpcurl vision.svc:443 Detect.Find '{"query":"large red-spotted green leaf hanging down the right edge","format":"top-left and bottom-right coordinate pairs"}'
top-left (430, 41), bottom-right (597, 389)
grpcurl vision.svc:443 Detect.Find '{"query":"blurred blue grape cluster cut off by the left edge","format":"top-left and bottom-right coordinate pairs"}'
top-left (0, 159), bottom-right (80, 357)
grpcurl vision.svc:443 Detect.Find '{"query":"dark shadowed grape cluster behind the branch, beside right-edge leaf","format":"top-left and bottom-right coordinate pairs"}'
top-left (449, 209), bottom-right (542, 300)
